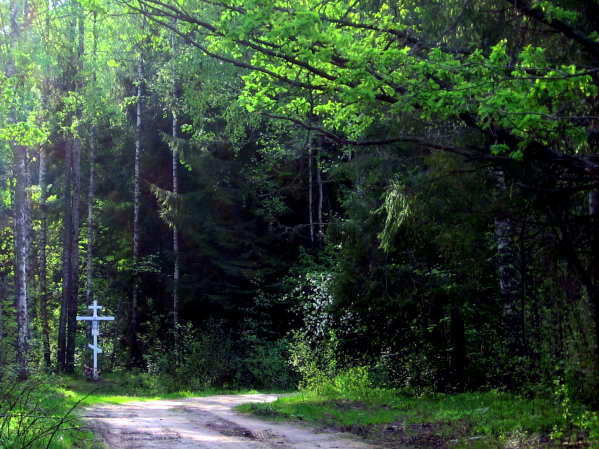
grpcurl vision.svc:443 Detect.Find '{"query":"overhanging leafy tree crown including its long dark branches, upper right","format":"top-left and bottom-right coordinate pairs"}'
top-left (119, 0), bottom-right (599, 170)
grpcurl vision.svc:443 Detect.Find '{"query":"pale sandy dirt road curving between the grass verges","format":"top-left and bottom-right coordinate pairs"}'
top-left (84, 394), bottom-right (374, 449)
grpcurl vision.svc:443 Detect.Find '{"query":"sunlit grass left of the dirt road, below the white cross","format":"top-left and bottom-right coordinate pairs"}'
top-left (0, 374), bottom-right (274, 449)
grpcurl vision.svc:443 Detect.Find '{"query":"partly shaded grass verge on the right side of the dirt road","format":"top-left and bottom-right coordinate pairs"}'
top-left (238, 389), bottom-right (599, 449)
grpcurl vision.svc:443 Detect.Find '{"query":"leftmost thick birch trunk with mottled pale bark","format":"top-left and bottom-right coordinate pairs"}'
top-left (14, 145), bottom-right (29, 379)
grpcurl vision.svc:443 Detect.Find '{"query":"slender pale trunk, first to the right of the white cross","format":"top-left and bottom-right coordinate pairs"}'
top-left (129, 55), bottom-right (143, 365)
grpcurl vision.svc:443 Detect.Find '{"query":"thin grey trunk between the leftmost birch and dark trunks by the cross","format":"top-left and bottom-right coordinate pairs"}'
top-left (39, 145), bottom-right (52, 368)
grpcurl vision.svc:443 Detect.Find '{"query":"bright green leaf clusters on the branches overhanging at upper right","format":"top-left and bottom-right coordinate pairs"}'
top-left (164, 1), bottom-right (596, 159)
